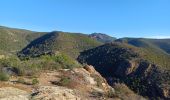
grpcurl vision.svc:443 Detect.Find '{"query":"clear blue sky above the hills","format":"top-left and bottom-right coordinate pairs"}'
top-left (0, 0), bottom-right (170, 38)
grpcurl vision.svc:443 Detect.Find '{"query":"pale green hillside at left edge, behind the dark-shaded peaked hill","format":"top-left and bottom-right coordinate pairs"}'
top-left (0, 26), bottom-right (44, 54)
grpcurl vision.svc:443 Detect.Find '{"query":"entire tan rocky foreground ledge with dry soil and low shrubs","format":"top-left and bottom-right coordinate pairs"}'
top-left (0, 66), bottom-right (144, 100)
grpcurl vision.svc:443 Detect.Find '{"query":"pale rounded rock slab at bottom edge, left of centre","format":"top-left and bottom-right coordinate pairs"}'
top-left (32, 86), bottom-right (80, 100)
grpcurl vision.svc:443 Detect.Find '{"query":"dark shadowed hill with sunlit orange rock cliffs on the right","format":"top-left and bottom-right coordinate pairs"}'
top-left (78, 43), bottom-right (170, 99)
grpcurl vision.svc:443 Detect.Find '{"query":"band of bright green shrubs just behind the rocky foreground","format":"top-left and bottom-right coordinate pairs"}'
top-left (0, 53), bottom-right (81, 76)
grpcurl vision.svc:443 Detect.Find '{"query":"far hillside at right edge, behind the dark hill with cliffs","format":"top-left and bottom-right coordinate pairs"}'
top-left (115, 38), bottom-right (170, 68)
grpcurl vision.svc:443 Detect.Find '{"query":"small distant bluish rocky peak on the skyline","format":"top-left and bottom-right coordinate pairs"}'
top-left (89, 33), bottom-right (116, 43)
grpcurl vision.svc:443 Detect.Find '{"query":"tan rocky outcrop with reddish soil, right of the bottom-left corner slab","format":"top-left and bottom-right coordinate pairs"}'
top-left (32, 65), bottom-right (119, 100)
